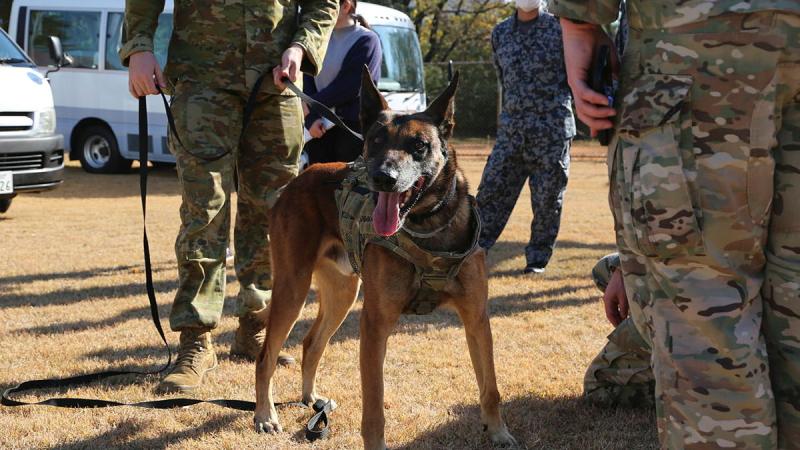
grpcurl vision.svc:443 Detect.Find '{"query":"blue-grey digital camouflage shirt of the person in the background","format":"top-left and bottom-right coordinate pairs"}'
top-left (492, 12), bottom-right (575, 140)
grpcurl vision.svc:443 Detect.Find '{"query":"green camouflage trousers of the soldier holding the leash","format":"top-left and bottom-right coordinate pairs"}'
top-left (169, 82), bottom-right (303, 331)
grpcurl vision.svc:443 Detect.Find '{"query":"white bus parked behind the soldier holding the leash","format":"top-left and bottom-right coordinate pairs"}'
top-left (9, 0), bottom-right (426, 173)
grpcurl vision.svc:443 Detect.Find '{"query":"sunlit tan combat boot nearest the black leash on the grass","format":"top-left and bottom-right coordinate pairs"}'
top-left (158, 329), bottom-right (217, 392)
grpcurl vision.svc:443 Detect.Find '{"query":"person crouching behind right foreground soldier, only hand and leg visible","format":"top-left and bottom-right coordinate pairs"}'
top-left (583, 253), bottom-right (655, 407)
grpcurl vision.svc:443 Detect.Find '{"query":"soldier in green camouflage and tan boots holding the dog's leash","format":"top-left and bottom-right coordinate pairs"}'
top-left (120, 0), bottom-right (338, 391)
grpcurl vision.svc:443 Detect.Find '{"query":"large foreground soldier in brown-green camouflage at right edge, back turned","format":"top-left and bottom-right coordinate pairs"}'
top-left (554, 0), bottom-right (800, 448)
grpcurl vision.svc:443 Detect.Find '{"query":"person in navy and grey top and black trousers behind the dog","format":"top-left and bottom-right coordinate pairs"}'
top-left (303, 0), bottom-right (382, 164)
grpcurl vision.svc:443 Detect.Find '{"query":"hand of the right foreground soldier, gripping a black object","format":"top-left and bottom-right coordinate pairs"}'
top-left (561, 18), bottom-right (619, 137)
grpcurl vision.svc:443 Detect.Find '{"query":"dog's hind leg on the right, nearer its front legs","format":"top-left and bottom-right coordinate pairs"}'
top-left (303, 256), bottom-right (360, 404)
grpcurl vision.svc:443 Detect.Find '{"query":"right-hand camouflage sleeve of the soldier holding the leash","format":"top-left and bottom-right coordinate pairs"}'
top-left (292, 0), bottom-right (339, 75)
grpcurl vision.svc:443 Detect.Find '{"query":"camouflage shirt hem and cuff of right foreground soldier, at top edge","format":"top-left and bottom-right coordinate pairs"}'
top-left (550, 0), bottom-right (800, 30)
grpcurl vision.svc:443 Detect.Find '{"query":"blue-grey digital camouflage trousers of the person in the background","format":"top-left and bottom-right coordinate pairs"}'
top-left (476, 124), bottom-right (572, 267)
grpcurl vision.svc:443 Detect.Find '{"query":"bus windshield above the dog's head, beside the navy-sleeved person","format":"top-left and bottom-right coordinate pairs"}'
top-left (372, 25), bottom-right (423, 92)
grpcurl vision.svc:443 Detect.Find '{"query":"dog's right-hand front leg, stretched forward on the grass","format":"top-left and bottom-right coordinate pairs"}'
top-left (453, 253), bottom-right (517, 447)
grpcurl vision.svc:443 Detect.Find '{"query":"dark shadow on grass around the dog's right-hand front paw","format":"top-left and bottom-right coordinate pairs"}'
top-left (398, 395), bottom-right (658, 450)
